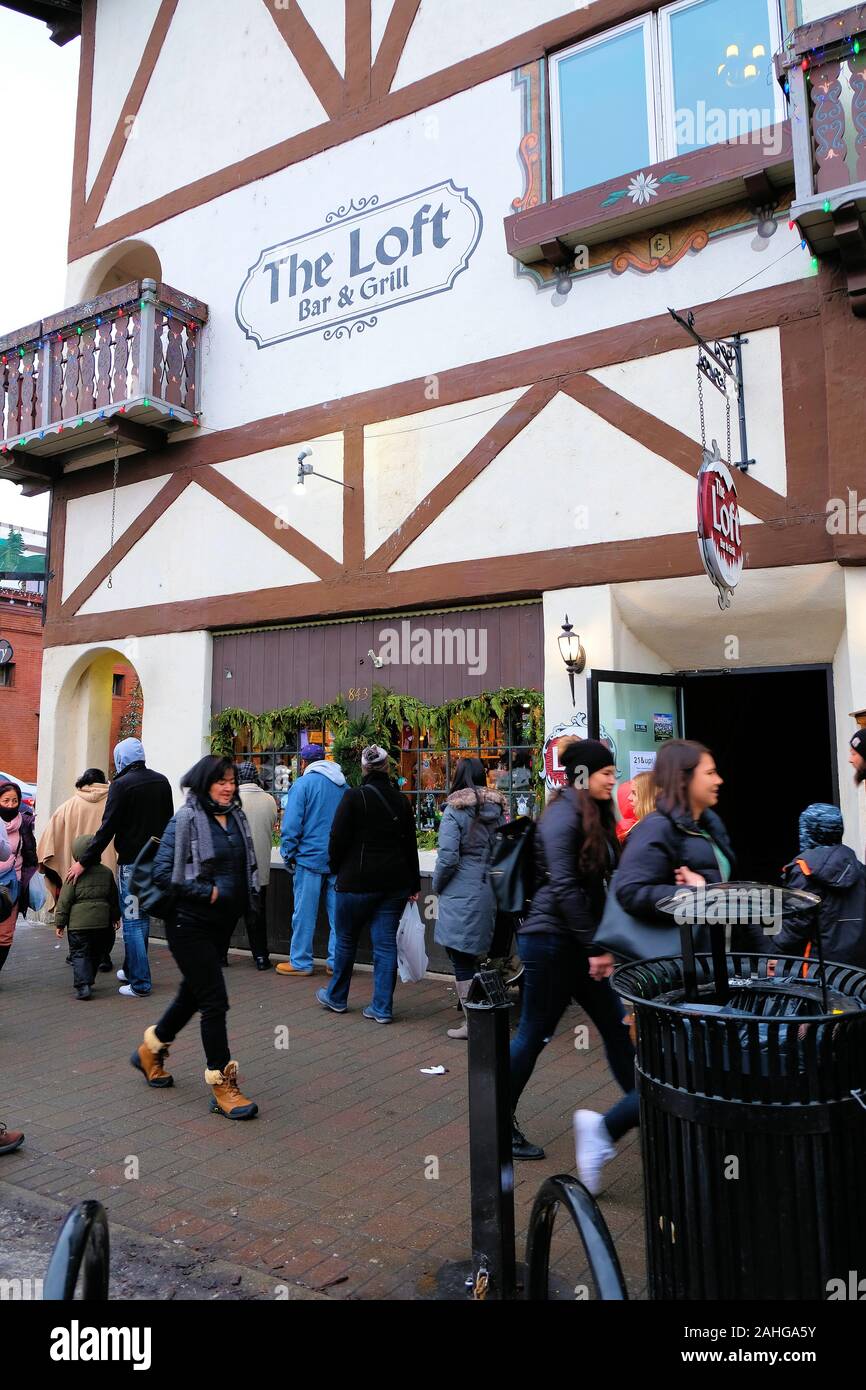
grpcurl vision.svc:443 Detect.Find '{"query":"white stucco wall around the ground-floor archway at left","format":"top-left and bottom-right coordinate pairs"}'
top-left (36, 632), bottom-right (213, 826)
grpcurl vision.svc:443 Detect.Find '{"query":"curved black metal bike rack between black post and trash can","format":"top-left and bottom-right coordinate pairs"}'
top-left (524, 1173), bottom-right (628, 1302)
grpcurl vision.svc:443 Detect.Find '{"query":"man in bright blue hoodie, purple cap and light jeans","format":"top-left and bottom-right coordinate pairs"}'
top-left (277, 744), bottom-right (346, 976)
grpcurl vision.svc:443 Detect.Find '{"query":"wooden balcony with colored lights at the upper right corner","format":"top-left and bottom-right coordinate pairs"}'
top-left (776, 4), bottom-right (866, 318)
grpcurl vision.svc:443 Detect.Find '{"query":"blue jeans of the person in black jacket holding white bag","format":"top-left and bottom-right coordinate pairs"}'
top-left (327, 892), bottom-right (407, 1019)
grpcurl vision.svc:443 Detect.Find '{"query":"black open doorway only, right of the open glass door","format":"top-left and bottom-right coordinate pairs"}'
top-left (684, 666), bottom-right (838, 883)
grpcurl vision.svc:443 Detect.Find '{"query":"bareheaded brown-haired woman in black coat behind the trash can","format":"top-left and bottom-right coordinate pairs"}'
top-left (616, 738), bottom-right (735, 927)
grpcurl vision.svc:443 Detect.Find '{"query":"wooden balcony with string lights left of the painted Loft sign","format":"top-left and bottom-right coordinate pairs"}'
top-left (0, 279), bottom-right (207, 493)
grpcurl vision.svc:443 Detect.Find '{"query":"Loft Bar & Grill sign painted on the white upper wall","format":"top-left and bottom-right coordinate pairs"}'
top-left (235, 179), bottom-right (484, 348)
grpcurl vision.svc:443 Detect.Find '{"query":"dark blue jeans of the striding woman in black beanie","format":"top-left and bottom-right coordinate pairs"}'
top-left (512, 931), bottom-right (635, 1108)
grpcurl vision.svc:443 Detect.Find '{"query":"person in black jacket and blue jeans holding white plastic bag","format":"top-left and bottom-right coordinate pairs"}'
top-left (322, 744), bottom-right (421, 1023)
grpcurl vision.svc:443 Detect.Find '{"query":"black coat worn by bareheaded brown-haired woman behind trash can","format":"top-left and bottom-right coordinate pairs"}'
top-left (616, 810), bottom-right (735, 926)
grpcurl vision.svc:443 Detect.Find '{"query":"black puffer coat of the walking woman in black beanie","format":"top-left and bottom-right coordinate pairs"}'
top-left (517, 787), bottom-right (617, 955)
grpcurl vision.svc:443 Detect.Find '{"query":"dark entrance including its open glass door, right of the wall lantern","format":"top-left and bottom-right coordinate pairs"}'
top-left (589, 666), bottom-right (838, 883)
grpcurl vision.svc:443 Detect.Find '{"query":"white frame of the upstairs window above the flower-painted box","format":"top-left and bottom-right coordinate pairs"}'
top-left (548, 0), bottom-right (788, 202)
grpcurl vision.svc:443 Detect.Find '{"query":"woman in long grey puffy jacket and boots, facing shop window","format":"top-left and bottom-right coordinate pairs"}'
top-left (432, 758), bottom-right (507, 1038)
